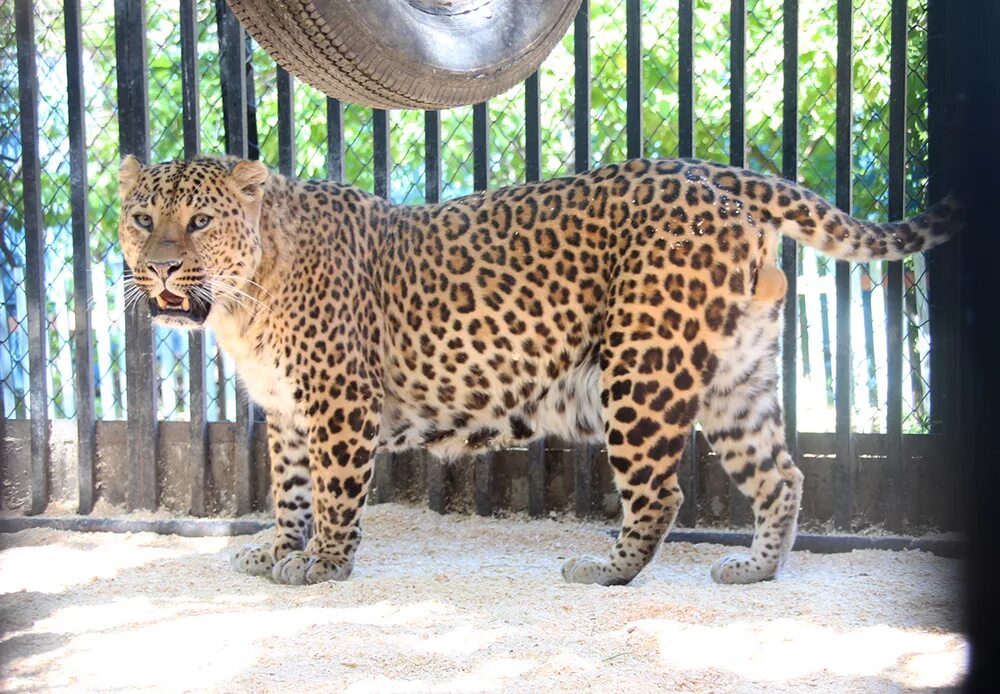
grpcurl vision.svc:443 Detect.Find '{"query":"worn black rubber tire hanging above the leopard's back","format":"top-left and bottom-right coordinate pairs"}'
top-left (227, 0), bottom-right (580, 109)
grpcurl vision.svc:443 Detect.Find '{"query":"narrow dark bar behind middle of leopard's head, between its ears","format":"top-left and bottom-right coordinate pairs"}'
top-left (180, 0), bottom-right (209, 516)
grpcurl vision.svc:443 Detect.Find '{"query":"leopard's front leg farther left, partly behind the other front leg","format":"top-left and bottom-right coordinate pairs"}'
top-left (233, 412), bottom-right (313, 576)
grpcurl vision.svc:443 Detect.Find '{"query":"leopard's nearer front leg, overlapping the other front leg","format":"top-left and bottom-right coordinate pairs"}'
top-left (272, 388), bottom-right (381, 585)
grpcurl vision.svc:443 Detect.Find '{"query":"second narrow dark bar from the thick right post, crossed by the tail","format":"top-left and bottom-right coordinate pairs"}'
top-left (833, 0), bottom-right (854, 530)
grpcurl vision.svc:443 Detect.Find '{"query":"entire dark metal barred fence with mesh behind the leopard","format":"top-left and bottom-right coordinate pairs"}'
top-left (0, 0), bottom-right (957, 530)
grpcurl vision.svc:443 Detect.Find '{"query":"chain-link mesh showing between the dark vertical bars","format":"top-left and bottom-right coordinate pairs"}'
top-left (0, 0), bottom-right (932, 433)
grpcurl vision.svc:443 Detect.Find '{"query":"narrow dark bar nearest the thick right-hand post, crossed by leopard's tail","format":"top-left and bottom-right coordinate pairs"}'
top-left (885, 0), bottom-right (907, 532)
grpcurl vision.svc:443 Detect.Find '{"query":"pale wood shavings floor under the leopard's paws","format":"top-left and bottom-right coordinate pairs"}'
top-left (0, 504), bottom-right (968, 694)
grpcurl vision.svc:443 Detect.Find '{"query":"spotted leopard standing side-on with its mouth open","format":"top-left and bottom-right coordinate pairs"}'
top-left (119, 155), bottom-right (961, 586)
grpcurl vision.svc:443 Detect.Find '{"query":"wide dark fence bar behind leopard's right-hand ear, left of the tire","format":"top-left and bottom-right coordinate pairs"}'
top-left (216, 0), bottom-right (256, 515)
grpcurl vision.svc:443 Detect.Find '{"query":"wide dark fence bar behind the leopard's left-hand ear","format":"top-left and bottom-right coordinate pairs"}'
top-left (115, 0), bottom-right (159, 510)
